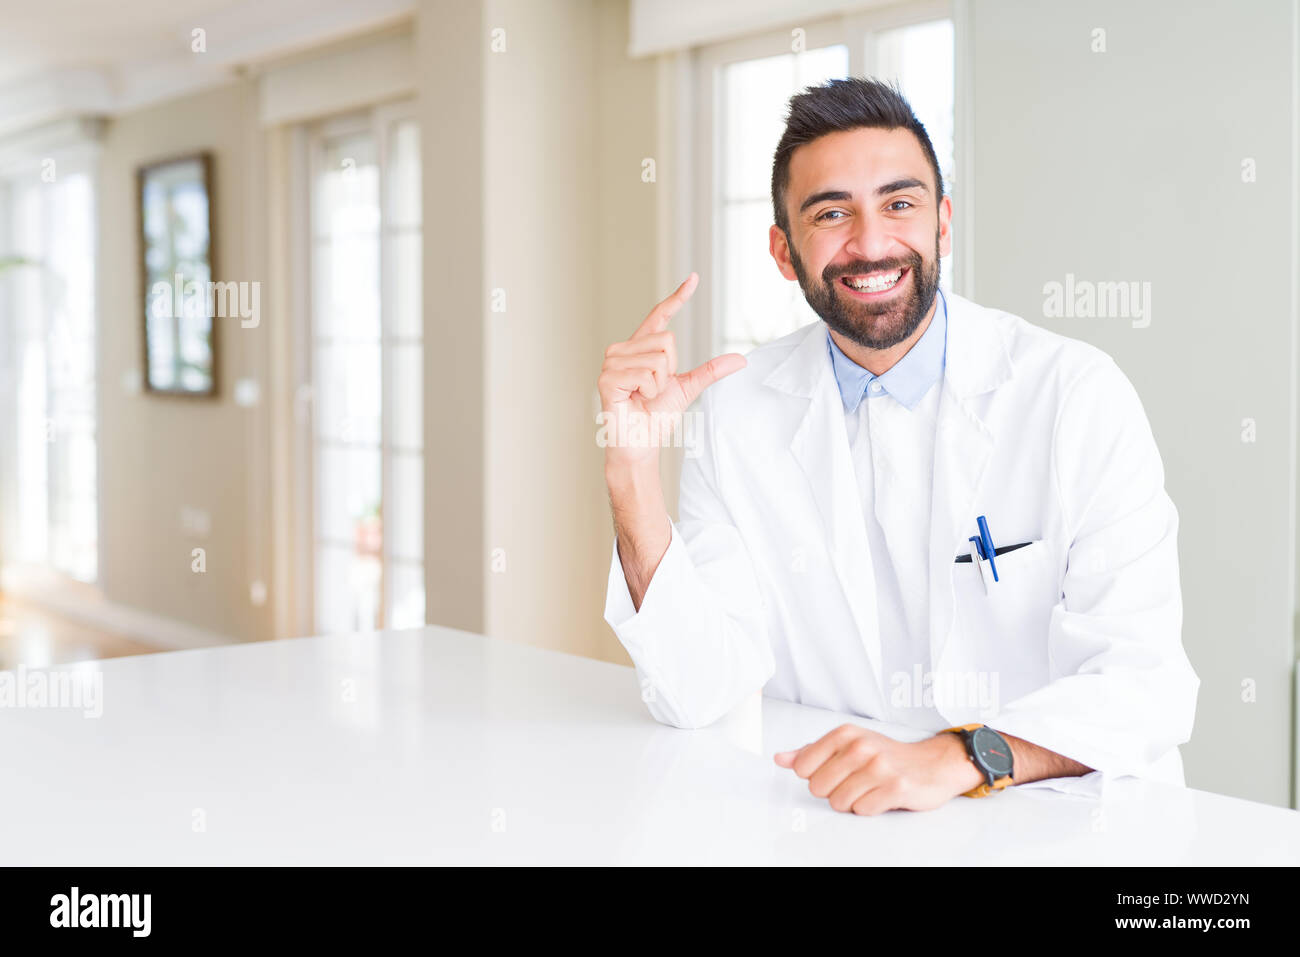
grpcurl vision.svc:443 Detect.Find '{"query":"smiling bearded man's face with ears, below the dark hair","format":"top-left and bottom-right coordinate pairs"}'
top-left (770, 129), bottom-right (952, 348)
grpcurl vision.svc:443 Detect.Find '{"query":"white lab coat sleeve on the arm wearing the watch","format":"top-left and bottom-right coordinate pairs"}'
top-left (987, 358), bottom-right (1200, 778)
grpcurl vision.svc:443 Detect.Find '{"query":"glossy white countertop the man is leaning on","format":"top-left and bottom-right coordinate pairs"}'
top-left (0, 627), bottom-right (1300, 866)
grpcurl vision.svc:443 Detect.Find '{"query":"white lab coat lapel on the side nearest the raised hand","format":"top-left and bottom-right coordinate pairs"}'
top-left (764, 322), bottom-right (881, 693)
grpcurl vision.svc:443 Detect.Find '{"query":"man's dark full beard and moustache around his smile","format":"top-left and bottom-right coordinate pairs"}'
top-left (789, 231), bottom-right (939, 348)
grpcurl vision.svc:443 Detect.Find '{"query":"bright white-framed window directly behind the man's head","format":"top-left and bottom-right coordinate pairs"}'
top-left (697, 7), bottom-right (956, 355)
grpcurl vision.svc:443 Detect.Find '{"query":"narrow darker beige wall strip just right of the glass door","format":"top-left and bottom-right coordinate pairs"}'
top-left (416, 7), bottom-right (489, 632)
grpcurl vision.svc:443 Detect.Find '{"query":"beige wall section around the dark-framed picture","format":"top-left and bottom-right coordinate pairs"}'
top-left (98, 82), bottom-right (270, 638)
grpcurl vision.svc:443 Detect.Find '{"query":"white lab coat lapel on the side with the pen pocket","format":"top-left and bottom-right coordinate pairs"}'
top-left (930, 295), bottom-right (1013, 668)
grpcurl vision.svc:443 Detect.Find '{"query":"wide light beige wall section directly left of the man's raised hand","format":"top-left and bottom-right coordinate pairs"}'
top-left (473, 0), bottom-right (659, 661)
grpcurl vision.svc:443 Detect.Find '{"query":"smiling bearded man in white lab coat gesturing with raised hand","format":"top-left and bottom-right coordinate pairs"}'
top-left (598, 79), bottom-right (1200, 814)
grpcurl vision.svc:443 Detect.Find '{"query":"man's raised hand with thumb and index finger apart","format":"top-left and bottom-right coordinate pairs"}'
top-left (597, 273), bottom-right (745, 469)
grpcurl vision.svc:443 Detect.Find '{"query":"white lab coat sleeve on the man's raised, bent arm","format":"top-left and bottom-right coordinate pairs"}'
top-left (605, 384), bottom-right (776, 728)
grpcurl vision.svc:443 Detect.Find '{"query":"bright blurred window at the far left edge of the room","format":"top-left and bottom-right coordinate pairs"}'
top-left (0, 161), bottom-right (99, 583)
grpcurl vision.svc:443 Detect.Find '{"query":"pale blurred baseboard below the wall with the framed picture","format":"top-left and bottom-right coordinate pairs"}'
top-left (0, 567), bottom-right (239, 651)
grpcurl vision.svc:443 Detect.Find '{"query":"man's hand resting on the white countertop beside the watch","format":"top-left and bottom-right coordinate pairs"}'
top-left (775, 724), bottom-right (984, 814)
